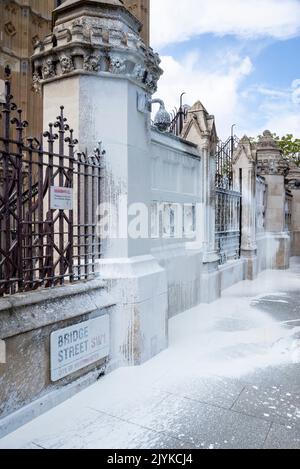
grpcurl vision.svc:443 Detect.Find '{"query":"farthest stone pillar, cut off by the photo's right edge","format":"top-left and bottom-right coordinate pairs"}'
top-left (286, 163), bottom-right (300, 256)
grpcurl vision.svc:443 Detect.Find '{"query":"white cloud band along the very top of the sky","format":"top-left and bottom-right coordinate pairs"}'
top-left (151, 0), bottom-right (300, 48)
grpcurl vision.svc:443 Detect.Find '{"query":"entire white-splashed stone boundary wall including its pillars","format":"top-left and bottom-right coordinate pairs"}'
top-left (0, 0), bottom-right (300, 434)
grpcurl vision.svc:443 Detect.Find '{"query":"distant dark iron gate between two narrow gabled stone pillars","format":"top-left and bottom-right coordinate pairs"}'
top-left (216, 137), bottom-right (242, 264)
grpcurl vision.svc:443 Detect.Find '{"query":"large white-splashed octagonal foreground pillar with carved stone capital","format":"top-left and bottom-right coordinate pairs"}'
top-left (33, 0), bottom-right (168, 366)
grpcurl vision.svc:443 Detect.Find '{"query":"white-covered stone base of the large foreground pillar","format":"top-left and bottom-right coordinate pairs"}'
top-left (98, 256), bottom-right (168, 367)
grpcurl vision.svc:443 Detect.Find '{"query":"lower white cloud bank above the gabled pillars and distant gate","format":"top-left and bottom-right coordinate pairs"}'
top-left (157, 52), bottom-right (300, 139)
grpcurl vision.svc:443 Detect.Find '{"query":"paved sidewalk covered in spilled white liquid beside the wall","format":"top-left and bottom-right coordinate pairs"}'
top-left (0, 259), bottom-right (300, 449)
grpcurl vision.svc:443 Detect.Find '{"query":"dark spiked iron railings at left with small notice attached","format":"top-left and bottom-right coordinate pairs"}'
top-left (0, 71), bottom-right (104, 296)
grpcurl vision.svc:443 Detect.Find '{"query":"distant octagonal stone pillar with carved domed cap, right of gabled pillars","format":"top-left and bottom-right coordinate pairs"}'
top-left (257, 131), bottom-right (290, 269)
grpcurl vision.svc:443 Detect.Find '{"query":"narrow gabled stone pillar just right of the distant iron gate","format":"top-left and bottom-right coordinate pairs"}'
top-left (233, 136), bottom-right (257, 280)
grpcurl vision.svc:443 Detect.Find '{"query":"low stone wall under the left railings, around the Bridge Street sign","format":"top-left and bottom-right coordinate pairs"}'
top-left (0, 280), bottom-right (114, 435)
